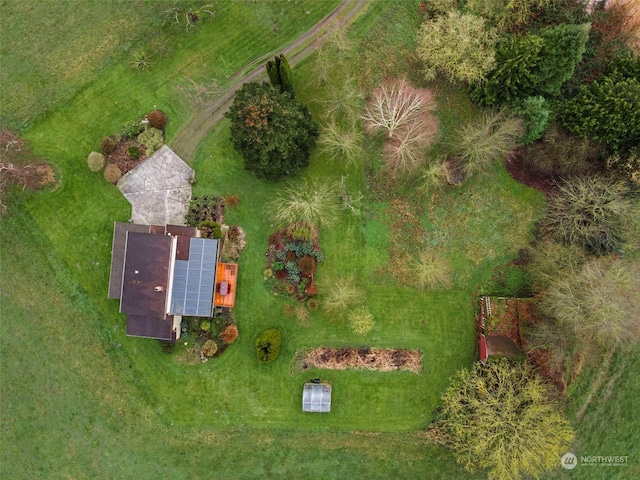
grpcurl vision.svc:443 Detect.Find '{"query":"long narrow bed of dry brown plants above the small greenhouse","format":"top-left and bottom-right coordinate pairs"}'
top-left (294, 347), bottom-right (422, 373)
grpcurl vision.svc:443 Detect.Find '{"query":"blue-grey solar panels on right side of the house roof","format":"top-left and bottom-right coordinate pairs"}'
top-left (169, 238), bottom-right (218, 317)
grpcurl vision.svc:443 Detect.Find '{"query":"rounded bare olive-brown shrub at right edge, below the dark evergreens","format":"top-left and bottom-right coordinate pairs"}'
top-left (543, 177), bottom-right (636, 255)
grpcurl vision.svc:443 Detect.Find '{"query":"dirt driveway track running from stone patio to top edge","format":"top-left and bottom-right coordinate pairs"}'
top-left (171, 0), bottom-right (370, 163)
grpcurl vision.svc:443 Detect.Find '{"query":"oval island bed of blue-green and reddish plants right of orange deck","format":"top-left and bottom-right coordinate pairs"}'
top-left (264, 224), bottom-right (324, 300)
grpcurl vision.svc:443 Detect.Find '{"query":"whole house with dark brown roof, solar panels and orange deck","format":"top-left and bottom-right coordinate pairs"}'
top-left (108, 222), bottom-right (237, 341)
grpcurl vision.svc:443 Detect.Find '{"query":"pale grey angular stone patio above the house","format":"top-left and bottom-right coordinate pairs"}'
top-left (117, 145), bottom-right (194, 225)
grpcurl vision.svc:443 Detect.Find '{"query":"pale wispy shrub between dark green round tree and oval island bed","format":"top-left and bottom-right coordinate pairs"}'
top-left (267, 179), bottom-right (339, 229)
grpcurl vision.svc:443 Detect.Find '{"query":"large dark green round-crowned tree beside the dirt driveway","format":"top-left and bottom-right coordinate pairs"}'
top-left (226, 82), bottom-right (318, 180)
